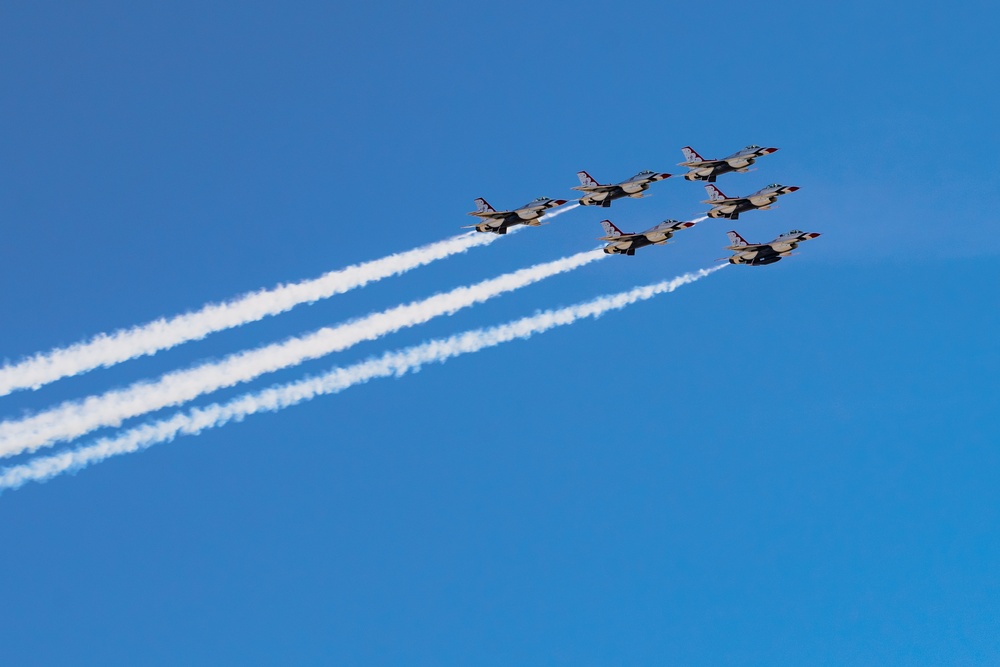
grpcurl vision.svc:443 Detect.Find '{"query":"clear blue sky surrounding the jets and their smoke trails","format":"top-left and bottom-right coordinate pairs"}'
top-left (0, 1), bottom-right (1000, 666)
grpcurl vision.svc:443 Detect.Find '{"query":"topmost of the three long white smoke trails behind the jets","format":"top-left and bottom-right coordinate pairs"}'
top-left (0, 232), bottom-right (499, 396)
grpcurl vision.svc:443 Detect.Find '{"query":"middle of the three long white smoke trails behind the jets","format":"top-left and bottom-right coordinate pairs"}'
top-left (0, 249), bottom-right (606, 456)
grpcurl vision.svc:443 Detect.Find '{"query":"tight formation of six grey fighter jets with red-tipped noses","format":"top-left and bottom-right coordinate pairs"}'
top-left (468, 145), bottom-right (820, 266)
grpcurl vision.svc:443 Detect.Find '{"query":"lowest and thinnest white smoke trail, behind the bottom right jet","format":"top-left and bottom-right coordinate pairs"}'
top-left (0, 264), bottom-right (729, 490)
